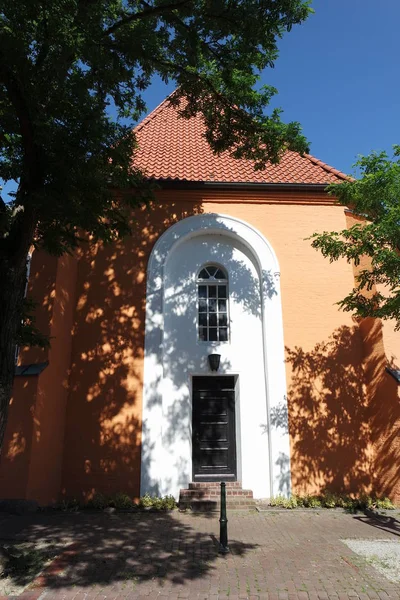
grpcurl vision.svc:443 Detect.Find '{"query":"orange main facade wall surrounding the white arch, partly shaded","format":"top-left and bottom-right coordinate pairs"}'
top-left (0, 190), bottom-right (400, 503)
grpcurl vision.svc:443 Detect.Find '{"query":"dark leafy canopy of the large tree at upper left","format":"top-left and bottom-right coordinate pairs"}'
top-left (0, 0), bottom-right (310, 254)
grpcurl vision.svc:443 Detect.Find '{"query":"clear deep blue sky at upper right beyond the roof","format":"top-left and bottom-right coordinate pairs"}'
top-left (1, 0), bottom-right (400, 199)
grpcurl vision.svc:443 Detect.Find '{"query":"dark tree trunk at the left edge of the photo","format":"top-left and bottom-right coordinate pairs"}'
top-left (0, 254), bottom-right (26, 453)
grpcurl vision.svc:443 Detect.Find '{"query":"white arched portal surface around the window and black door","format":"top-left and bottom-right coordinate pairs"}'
top-left (141, 214), bottom-right (290, 498)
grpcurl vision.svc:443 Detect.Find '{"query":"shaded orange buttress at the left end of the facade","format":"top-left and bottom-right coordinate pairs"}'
top-left (0, 252), bottom-right (76, 504)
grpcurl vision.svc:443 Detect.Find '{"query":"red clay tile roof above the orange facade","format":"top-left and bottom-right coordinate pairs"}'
top-left (134, 98), bottom-right (347, 184)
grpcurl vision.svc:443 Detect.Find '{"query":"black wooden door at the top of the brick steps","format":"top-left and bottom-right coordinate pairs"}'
top-left (192, 376), bottom-right (236, 481)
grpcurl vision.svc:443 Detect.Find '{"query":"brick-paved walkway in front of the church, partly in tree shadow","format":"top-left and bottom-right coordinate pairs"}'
top-left (0, 511), bottom-right (400, 600)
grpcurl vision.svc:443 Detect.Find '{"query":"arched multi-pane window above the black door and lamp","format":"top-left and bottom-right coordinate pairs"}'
top-left (197, 265), bottom-right (229, 342)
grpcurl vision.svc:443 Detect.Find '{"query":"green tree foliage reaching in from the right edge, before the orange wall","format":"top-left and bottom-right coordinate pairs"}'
top-left (311, 146), bottom-right (400, 329)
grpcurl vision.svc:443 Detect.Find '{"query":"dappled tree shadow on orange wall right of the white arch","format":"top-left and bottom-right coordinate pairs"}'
top-left (284, 324), bottom-right (400, 497)
